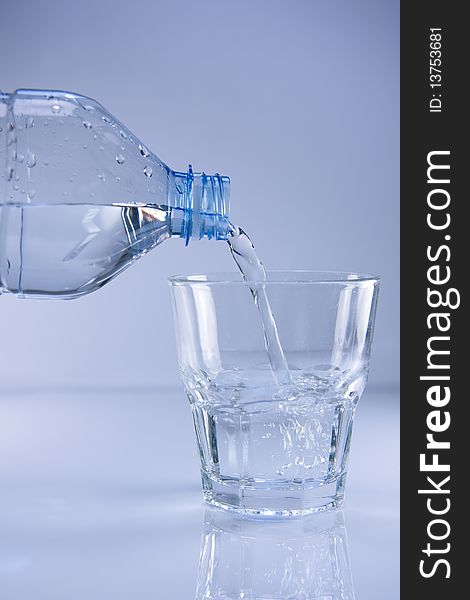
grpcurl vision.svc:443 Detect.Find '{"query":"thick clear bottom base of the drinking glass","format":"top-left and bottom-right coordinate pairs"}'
top-left (202, 472), bottom-right (346, 517)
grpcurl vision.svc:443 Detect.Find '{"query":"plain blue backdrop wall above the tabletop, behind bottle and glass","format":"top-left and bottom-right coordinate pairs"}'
top-left (0, 0), bottom-right (399, 390)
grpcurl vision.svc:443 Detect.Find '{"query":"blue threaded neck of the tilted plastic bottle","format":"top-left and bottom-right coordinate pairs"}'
top-left (170, 165), bottom-right (230, 244)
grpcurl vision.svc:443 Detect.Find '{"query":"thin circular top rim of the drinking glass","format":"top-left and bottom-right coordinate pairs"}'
top-left (168, 270), bottom-right (380, 286)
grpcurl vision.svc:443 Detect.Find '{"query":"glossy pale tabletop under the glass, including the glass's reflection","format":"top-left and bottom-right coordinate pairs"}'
top-left (0, 387), bottom-right (399, 600)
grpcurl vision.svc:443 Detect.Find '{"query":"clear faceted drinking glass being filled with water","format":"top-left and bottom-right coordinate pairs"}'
top-left (170, 271), bottom-right (379, 516)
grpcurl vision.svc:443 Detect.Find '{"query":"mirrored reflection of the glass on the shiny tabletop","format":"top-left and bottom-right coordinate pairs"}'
top-left (196, 509), bottom-right (354, 600)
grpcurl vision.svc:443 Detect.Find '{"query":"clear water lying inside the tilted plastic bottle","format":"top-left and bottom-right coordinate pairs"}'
top-left (0, 204), bottom-right (178, 298)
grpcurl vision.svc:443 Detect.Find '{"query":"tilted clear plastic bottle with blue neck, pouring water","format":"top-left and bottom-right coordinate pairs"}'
top-left (0, 90), bottom-right (230, 298)
